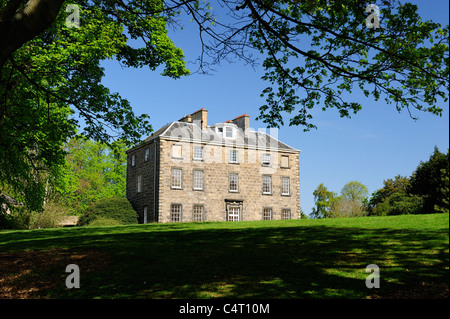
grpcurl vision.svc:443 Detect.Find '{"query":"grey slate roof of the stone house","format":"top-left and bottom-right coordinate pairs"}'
top-left (145, 121), bottom-right (299, 152)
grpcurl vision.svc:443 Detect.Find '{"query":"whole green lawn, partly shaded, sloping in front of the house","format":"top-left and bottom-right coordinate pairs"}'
top-left (0, 214), bottom-right (449, 298)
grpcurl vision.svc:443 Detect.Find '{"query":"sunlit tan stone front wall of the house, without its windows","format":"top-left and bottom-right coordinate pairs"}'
top-left (156, 139), bottom-right (300, 222)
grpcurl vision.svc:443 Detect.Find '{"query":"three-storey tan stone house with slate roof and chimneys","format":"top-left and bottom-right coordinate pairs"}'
top-left (126, 108), bottom-right (300, 223)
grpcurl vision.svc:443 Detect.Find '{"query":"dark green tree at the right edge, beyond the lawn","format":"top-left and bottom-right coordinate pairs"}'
top-left (408, 147), bottom-right (450, 213)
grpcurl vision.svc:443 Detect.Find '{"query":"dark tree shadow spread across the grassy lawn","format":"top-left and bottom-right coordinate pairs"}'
top-left (0, 225), bottom-right (449, 298)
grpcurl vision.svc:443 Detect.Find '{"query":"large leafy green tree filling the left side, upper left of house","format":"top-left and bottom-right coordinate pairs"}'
top-left (0, 0), bottom-right (188, 211)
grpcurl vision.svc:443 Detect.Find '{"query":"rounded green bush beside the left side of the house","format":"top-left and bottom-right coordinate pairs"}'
top-left (78, 197), bottom-right (138, 225)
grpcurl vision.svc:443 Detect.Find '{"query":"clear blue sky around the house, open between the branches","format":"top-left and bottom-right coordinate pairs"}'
top-left (103, 0), bottom-right (449, 218)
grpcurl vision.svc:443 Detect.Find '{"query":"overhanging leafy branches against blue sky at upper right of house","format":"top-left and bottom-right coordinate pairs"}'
top-left (185, 0), bottom-right (449, 130)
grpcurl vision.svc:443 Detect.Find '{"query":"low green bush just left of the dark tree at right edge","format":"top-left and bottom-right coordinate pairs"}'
top-left (373, 192), bottom-right (424, 216)
